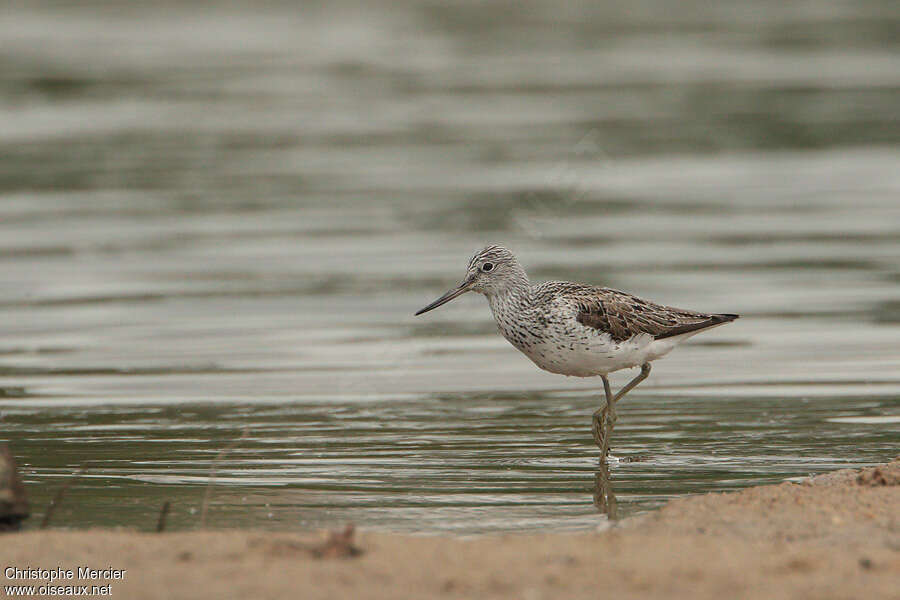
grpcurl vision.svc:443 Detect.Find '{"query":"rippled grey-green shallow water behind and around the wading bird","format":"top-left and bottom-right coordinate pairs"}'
top-left (0, 2), bottom-right (900, 532)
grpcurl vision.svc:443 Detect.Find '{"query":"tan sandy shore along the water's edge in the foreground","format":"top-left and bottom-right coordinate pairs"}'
top-left (0, 459), bottom-right (900, 600)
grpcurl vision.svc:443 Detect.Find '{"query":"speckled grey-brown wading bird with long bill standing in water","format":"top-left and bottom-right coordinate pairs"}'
top-left (416, 246), bottom-right (738, 459)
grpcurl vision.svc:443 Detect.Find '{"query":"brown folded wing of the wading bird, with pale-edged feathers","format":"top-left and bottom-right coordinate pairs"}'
top-left (575, 288), bottom-right (738, 342)
